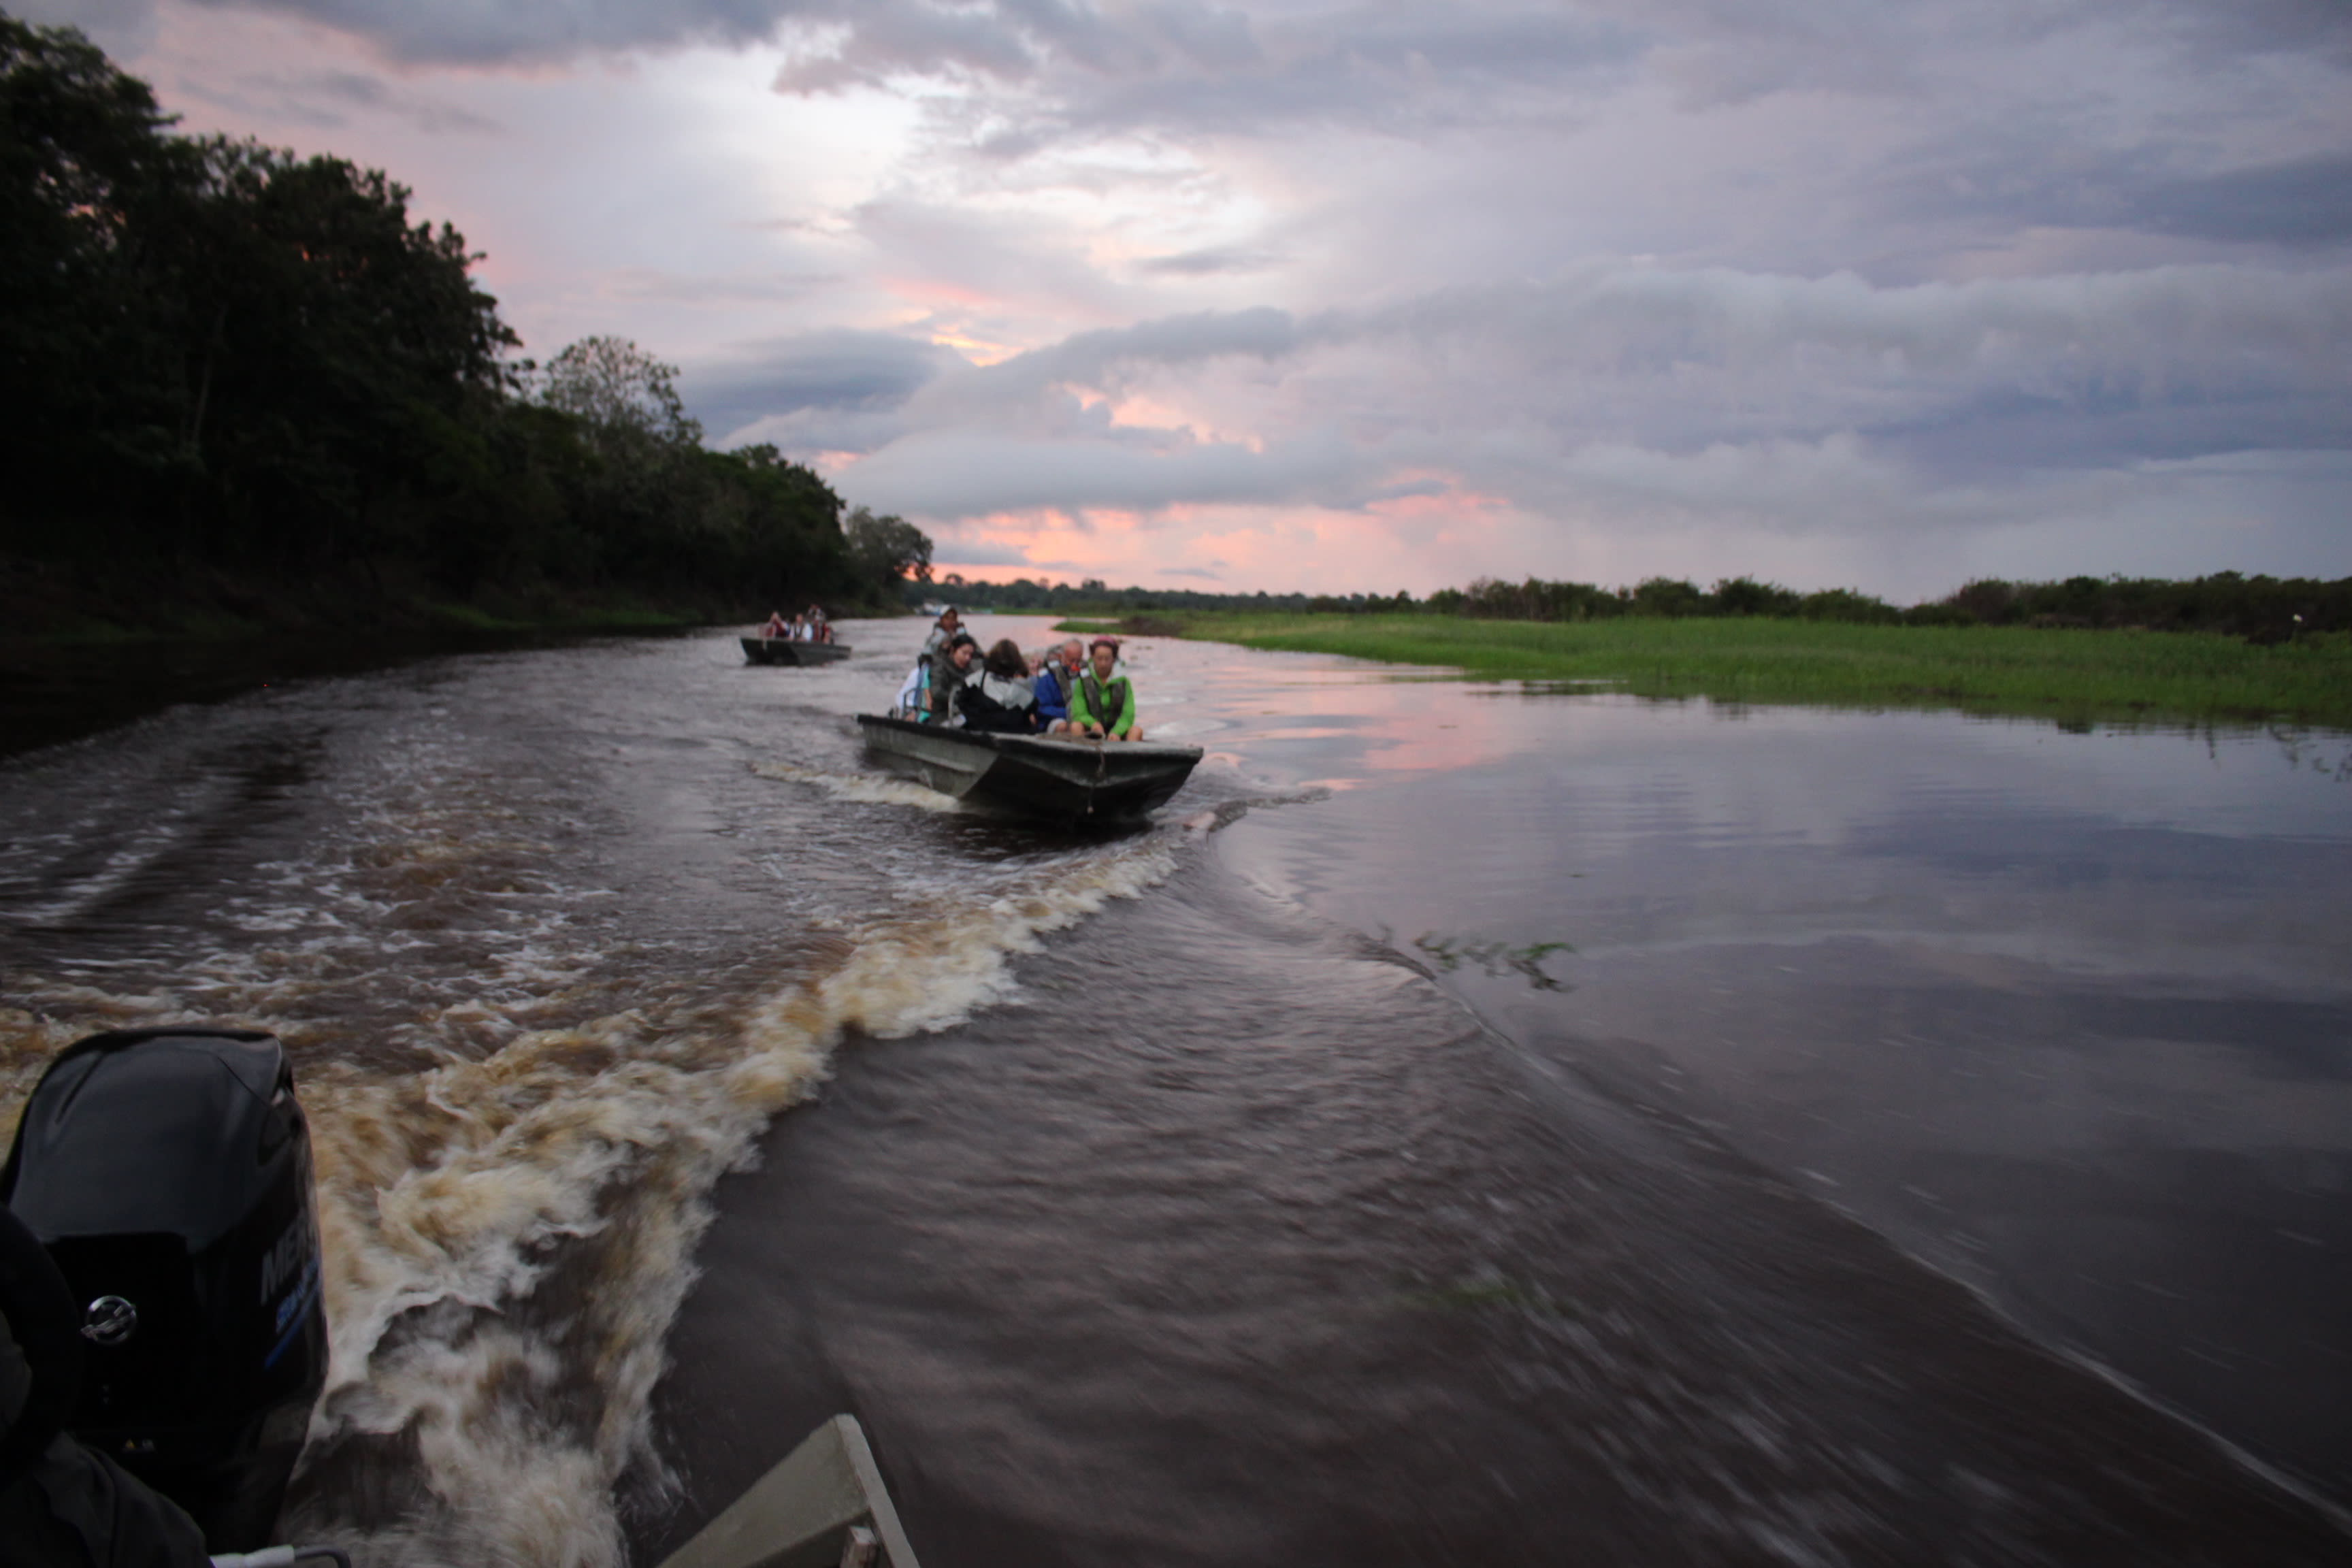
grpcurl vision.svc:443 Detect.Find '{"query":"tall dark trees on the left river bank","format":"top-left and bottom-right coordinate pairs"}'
top-left (0, 14), bottom-right (929, 614)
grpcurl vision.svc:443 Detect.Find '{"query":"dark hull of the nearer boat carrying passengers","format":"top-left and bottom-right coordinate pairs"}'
top-left (858, 713), bottom-right (1200, 823)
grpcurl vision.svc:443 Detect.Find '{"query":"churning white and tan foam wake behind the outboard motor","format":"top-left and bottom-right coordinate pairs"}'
top-left (0, 841), bottom-right (1176, 1568)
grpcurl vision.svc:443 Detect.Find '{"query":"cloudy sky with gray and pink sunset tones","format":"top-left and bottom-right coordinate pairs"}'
top-left (32, 0), bottom-right (2352, 600)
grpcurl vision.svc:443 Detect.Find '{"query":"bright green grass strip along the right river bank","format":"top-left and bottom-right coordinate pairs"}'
top-left (1066, 614), bottom-right (2352, 729)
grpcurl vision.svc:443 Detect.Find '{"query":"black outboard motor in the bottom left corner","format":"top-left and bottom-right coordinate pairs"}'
top-left (0, 1025), bottom-right (327, 1552)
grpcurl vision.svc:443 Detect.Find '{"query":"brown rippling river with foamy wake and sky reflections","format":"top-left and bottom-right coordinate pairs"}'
top-left (0, 618), bottom-right (2352, 1568)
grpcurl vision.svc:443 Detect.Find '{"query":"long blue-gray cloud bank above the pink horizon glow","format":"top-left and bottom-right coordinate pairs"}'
top-left (795, 265), bottom-right (2352, 524)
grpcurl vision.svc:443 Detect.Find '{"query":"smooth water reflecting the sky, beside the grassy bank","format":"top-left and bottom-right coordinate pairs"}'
top-left (1223, 700), bottom-right (2352, 1495)
